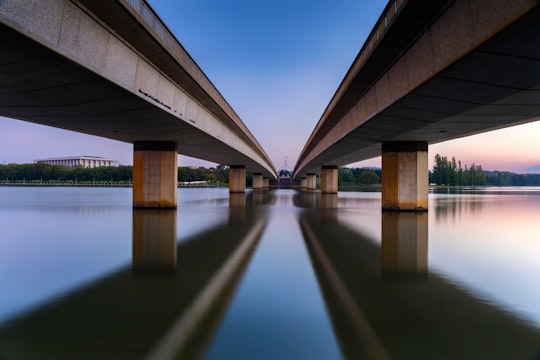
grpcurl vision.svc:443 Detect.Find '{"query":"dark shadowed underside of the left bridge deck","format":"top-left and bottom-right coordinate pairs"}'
top-left (0, 24), bottom-right (274, 177)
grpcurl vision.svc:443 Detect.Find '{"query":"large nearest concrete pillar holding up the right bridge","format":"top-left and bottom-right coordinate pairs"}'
top-left (382, 141), bottom-right (429, 211)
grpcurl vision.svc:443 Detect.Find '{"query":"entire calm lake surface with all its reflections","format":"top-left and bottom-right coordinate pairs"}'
top-left (0, 187), bottom-right (540, 360)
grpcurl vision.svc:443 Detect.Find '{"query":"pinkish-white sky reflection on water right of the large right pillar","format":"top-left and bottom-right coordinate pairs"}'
top-left (429, 189), bottom-right (540, 327)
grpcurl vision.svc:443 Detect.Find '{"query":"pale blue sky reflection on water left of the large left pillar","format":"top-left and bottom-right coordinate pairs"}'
top-left (0, 187), bottom-right (131, 320)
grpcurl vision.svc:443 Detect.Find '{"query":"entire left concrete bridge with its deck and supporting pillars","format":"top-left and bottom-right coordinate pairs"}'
top-left (0, 0), bottom-right (277, 207)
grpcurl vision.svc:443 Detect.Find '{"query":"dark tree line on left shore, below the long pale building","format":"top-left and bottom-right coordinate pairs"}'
top-left (0, 163), bottom-right (229, 184)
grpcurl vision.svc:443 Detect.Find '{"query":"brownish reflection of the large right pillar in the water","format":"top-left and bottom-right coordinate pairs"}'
top-left (381, 211), bottom-right (428, 275)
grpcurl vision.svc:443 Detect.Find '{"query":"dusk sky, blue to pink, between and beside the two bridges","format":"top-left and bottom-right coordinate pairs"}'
top-left (0, 0), bottom-right (540, 173)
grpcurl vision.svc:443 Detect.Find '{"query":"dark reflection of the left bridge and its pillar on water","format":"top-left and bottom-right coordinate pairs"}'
top-left (0, 197), bottom-right (267, 359)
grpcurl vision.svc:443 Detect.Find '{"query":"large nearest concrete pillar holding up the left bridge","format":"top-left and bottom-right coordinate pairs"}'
top-left (133, 141), bottom-right (178, 208)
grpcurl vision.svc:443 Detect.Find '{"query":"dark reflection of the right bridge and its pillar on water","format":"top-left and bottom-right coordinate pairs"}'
top-left (299, 208), bottom-right (540, 359)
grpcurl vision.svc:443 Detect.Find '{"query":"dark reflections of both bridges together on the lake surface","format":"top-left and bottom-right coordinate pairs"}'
top-left (0, 191), bottom-right (540, 359)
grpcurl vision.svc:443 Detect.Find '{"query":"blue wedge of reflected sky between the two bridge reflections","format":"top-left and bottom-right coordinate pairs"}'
top-left (207, 191), bottom-right (341, 359)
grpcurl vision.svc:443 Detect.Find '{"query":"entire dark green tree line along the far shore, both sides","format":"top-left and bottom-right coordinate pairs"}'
top-left (0, 161), bottom-right (540, 186)
